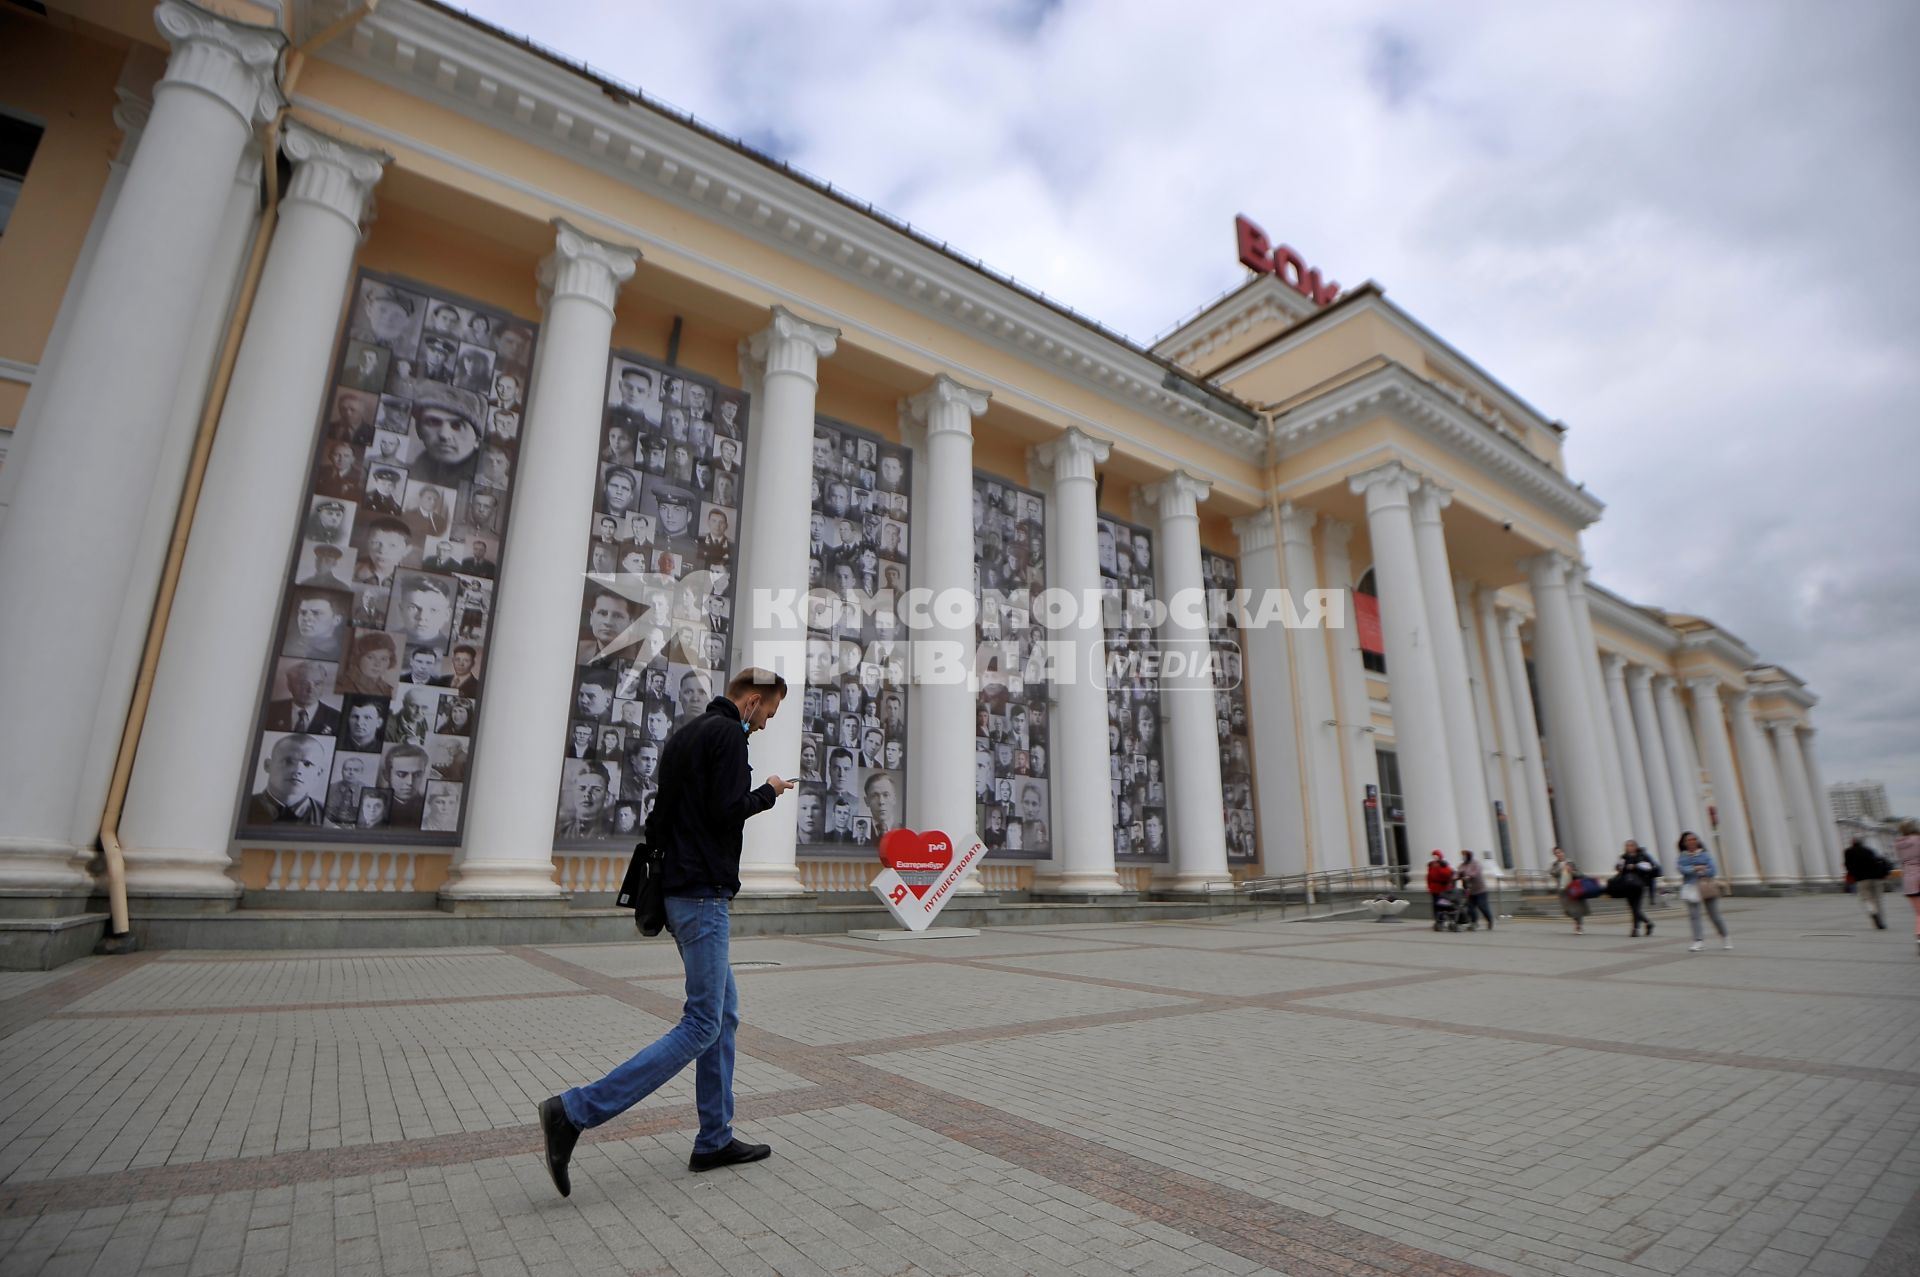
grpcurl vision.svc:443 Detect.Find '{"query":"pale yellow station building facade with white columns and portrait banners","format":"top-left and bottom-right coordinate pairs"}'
top-left (0, 0), bottom-right (1837, 944)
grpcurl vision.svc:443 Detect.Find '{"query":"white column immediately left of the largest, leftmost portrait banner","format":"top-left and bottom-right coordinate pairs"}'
top-left (121, 123), bottom-right (386, 899)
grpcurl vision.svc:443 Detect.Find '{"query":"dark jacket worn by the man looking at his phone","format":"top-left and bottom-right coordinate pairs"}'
top-left (647, 697), bottom-right (776, 897)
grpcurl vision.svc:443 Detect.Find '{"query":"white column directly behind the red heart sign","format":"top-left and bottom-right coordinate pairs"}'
top-left (906, 374), bottom-right (989, 893)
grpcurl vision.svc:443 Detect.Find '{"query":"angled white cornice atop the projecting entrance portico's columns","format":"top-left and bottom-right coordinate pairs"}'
top-left (1273, 363), bottom-right (1605, 528)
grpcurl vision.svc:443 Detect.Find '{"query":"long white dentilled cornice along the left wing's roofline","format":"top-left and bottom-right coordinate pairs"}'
top-left (321, 0), bottom-right (1265, 461)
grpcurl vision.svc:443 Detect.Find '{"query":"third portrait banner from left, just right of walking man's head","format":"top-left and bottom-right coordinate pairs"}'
top-left (795, 417), bottom-right (912, 856)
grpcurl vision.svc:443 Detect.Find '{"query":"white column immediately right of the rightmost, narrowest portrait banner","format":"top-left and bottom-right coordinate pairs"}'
top-left (1236, 511), bottom-right (1313, 876)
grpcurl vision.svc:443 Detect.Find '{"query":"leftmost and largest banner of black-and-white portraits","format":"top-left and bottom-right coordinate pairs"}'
top-left (238, 271), bottom-right (538, 847)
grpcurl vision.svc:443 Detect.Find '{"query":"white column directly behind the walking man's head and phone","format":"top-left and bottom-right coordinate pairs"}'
top-left (733, 305), bottom-right (837, 895)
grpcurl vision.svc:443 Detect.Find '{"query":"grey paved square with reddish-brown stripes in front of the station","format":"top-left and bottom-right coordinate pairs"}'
top-left (0, 897), bottom-right (1920, 1277)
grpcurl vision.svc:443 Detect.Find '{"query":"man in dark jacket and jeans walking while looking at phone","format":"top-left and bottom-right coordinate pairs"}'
top-left (540, 668), bottom-right (793, 1196)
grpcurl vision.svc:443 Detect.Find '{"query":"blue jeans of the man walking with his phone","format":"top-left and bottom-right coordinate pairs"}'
top-left (561, 895), bottom-right (739, 1152)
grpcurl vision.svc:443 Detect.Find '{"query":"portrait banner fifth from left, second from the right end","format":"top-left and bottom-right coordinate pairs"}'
top-left (1096, 515), bottom-right (1169, 864)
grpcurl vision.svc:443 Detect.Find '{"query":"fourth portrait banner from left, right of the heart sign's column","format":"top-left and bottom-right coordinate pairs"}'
top-left (973, 472), bottom-right (1054, 860)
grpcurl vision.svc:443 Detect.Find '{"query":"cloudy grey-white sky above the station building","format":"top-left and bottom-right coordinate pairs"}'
top-left (474, 0), bottom-right (1920, 814)
